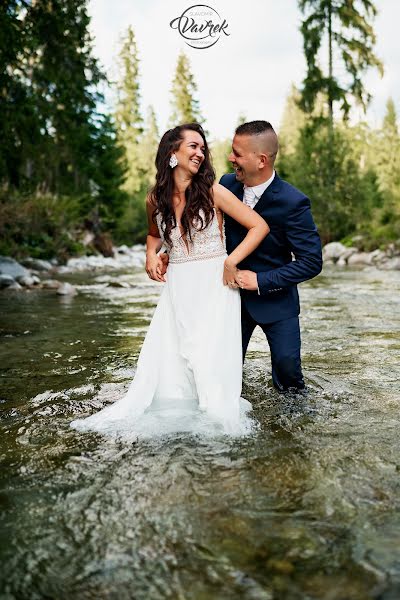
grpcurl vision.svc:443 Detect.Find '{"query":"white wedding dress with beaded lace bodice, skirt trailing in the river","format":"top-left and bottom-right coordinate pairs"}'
top-left (71, 209), bottom-right (253, 438)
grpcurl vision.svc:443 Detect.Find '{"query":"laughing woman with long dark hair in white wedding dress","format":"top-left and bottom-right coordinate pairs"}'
top-left (71, 123), bottom-right (269, 437)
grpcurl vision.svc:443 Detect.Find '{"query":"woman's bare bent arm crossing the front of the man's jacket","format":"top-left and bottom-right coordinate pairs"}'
top-left (213, 183), bottom-right (269, 280)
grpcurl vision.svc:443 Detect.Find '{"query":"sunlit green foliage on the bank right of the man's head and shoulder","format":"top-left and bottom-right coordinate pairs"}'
top-left (277, 84), bottom-right (400, 251)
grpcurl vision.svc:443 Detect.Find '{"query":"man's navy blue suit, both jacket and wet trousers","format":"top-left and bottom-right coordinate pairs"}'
top-left (220, 173), bottom-right (322, 391)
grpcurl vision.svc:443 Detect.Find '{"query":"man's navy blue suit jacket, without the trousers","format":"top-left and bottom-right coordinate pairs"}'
top-left (220, 173), bottom-right (322, 323)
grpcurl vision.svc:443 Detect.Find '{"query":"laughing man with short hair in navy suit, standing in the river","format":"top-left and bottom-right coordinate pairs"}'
top-left (220, 121), bottom-right (322, 392)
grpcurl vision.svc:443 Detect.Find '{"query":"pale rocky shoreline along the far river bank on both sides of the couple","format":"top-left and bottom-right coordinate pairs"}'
top-left (0, 242), bottom-right (400, 296)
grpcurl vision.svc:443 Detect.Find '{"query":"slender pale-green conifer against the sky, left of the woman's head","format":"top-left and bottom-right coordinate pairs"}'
top-left (115, 26), bottom-right (143, 195)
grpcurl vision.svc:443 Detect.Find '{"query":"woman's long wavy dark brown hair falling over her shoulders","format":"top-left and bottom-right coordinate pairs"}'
top-left (150, 123), bottom-right (215, 244)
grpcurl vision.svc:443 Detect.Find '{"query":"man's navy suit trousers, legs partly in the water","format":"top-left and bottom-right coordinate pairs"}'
top-left (242, 302), bottom-right (305, 392)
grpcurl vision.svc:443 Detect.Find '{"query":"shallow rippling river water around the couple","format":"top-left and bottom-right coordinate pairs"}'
top-left (0, 269), bottom-right (400, 600)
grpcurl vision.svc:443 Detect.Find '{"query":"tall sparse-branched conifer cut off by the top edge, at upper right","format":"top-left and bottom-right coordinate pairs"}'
top-left (299, 0), bottom-right (383, 127)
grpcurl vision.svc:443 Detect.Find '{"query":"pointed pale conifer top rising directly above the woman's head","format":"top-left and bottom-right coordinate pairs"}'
top-left (170, 52), bottom-right (204, 127)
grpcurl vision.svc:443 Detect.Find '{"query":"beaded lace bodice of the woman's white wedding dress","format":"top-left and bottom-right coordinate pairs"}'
top-left (156, 209), bottom-right (226, 263)
